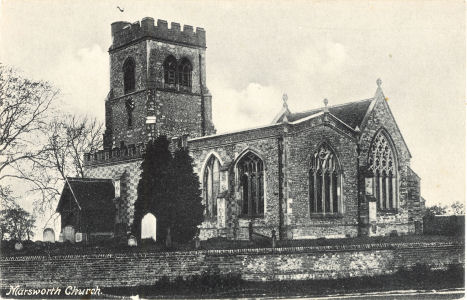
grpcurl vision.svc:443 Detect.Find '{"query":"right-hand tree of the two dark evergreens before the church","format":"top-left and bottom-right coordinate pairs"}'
top-left (168, 149), bottom-right (204, 243)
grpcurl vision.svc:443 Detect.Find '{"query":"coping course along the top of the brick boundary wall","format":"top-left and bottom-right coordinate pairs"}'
top-left (0, 241), bottom-right (465, 262)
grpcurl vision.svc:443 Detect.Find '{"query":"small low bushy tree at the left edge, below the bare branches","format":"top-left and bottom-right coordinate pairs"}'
top-left (0, 206), bottom-right (36, 241)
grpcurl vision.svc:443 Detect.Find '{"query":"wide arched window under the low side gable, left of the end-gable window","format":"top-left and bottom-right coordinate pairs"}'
top-left (308, 144), bottom-right (342, 214)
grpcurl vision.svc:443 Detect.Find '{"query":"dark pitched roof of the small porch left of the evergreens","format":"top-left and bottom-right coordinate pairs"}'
top-left (57, 177), bottom-right (115, 212)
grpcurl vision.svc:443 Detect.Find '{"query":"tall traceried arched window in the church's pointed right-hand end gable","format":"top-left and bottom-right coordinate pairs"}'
top-left (368, 130), bottom-right (397, 210)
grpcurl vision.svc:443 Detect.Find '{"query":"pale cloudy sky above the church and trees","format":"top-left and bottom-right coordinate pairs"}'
top-left (0, 0), bottom-right (466, 233)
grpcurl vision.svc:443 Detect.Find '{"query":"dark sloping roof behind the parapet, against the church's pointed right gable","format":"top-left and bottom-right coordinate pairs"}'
top-left (278, 98), bottom-right (373, 129)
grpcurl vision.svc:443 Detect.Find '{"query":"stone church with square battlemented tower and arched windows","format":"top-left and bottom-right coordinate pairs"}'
top-left (56, 17), bottom-right (423, 239)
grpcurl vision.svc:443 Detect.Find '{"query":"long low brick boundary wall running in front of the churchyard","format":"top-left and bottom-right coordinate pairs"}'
top-left (0, 242), bottom-right (465, 289)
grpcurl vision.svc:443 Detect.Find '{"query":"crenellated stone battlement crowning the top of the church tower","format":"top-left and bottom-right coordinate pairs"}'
top-left (110, 17), bottom-right (206, 50)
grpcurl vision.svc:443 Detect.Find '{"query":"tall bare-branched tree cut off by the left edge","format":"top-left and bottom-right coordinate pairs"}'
top-left (0, 63), bottom-right (58, 184)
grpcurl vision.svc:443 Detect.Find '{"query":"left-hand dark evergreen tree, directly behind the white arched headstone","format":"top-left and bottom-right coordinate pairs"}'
top-left (133, 136), bottom-right (172, 241)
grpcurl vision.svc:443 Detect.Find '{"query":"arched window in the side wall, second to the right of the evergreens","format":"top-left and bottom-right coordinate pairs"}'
top-left (237, 152), bottom-right (264, 217)
